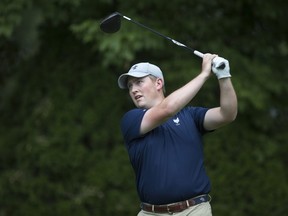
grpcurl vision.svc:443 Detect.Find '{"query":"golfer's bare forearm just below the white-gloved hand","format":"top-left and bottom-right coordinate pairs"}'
top-left (219, 78), bottom-right (238, 121)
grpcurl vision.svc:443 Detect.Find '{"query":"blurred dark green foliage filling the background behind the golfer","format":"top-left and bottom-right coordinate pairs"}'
top-left (0, 0), bottom-right (288, 216)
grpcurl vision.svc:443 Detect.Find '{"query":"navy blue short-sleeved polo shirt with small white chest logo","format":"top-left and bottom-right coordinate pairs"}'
top-left (121, 107), bottom-right (211, 205)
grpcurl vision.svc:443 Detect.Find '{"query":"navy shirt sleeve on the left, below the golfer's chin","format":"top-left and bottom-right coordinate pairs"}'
top-left (121, 109), bottom-right (146, 145)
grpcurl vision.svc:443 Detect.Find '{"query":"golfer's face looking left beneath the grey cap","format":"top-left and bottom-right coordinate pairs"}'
top-left (127, 76), bottom-right (163, 109)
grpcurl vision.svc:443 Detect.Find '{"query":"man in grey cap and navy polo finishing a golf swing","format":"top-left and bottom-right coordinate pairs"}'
top-left (118, 54), bottom-right (237, 216)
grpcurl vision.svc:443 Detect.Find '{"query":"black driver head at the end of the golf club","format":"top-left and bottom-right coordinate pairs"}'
top-left (100, 12), bottom-right (122, 33)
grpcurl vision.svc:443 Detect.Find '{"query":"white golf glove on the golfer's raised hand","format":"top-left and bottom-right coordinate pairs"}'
top-left (212, 56), bottom-right (231, 79)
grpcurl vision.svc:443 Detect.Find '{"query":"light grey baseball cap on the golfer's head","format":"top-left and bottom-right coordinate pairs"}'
top-left (118, 62), bottom-right (164, 89)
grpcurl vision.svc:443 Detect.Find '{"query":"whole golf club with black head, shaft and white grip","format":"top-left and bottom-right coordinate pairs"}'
top-left (100, 12), bottom-right (225, 69)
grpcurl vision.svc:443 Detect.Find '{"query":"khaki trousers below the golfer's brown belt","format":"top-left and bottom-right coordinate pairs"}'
top-left (137, 202), bottom-right (212, 216)
